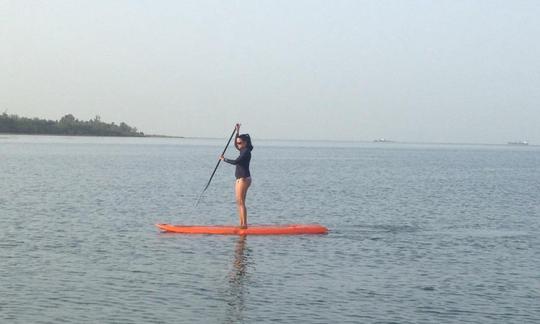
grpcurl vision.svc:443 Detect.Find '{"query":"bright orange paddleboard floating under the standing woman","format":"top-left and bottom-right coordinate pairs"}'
top-left (156, 224), bottom-right (328, 235)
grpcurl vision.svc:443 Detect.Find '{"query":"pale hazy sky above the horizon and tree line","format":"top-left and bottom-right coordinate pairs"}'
top-left (0, 0), bottom-right (540, 144)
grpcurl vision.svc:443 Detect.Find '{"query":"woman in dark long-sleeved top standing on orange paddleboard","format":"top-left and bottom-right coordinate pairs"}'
top-left (220, 124), bottom-right (253, 228)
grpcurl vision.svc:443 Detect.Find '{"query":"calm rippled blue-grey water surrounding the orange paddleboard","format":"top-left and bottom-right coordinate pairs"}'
top-left (0, 135), bottom-right (540, 323)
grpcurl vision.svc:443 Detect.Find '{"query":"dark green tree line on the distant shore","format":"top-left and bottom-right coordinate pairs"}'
top-left (0, 112), bottom-right (144, 136)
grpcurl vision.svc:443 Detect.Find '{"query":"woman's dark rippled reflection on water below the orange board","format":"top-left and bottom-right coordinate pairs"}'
top-left (225, 235), bottom-right (250, 323)
